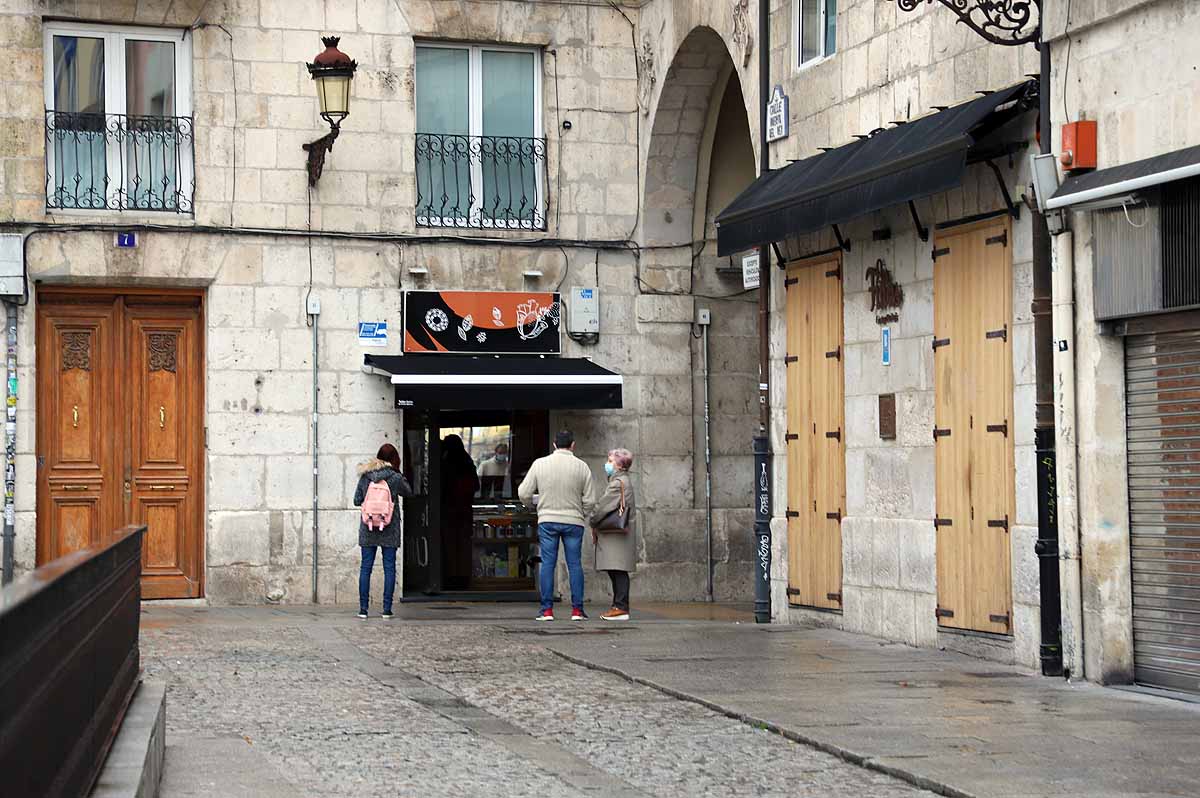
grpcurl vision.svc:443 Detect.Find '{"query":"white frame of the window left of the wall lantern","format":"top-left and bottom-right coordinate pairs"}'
top-left (42, 22), bottom-right (196, 215)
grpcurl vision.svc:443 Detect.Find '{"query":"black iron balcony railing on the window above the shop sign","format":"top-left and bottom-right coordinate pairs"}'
top-left (416, 133), bottom-right (547, 230)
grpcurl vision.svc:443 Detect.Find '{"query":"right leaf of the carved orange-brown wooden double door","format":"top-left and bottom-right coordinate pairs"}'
top-left (122, 298), bottom-right (203, 599)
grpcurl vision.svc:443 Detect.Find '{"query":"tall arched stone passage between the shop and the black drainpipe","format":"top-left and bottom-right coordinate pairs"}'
top-left (638, 25), bottom-right (757, 600)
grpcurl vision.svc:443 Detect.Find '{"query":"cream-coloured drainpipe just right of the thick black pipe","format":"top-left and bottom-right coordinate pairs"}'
top-left (1051, 232), bottom-right (1085, 679)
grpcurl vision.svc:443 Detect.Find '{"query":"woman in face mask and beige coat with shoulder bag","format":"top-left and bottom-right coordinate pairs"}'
top-left (592, 449), bottom-right (637, 620)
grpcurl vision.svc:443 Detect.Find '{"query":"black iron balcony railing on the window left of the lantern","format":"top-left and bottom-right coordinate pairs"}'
top-left (46, 110), bottom-right (196, 214)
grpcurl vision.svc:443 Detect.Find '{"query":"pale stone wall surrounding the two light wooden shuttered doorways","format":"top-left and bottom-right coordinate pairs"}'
top-left (744, 1), bottom-right (1042, 668)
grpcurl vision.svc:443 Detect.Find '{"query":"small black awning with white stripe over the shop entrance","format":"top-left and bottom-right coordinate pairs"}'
top-left (362, 355), bottom-right (622, 410)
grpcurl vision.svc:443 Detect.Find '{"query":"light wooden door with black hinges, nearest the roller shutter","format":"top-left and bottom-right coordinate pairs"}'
top-left (934, 218), bottom-right (1014, 635)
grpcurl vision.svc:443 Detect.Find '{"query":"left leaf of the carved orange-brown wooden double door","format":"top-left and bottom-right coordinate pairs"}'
top-left (37, 302), bottom-right (120, 564)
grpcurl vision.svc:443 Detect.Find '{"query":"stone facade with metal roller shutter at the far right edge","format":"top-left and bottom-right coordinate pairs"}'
top-left (1045, 0), bottom-right (1200, 692)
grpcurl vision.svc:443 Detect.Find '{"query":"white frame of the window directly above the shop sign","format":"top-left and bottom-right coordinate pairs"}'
top-left (413, 40), bottom-right (546, 230)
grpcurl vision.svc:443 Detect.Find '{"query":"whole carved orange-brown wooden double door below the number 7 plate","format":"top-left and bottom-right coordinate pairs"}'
top-left (37, 289), bottom-right (204, 599)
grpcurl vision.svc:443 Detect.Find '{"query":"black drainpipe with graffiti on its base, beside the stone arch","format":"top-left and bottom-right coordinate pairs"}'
top-left (754, 0), bottom-right (772, 624)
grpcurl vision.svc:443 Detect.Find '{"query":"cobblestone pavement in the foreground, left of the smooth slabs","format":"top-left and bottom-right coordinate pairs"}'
top-left (142, 611), bottom-right (931, 798)
